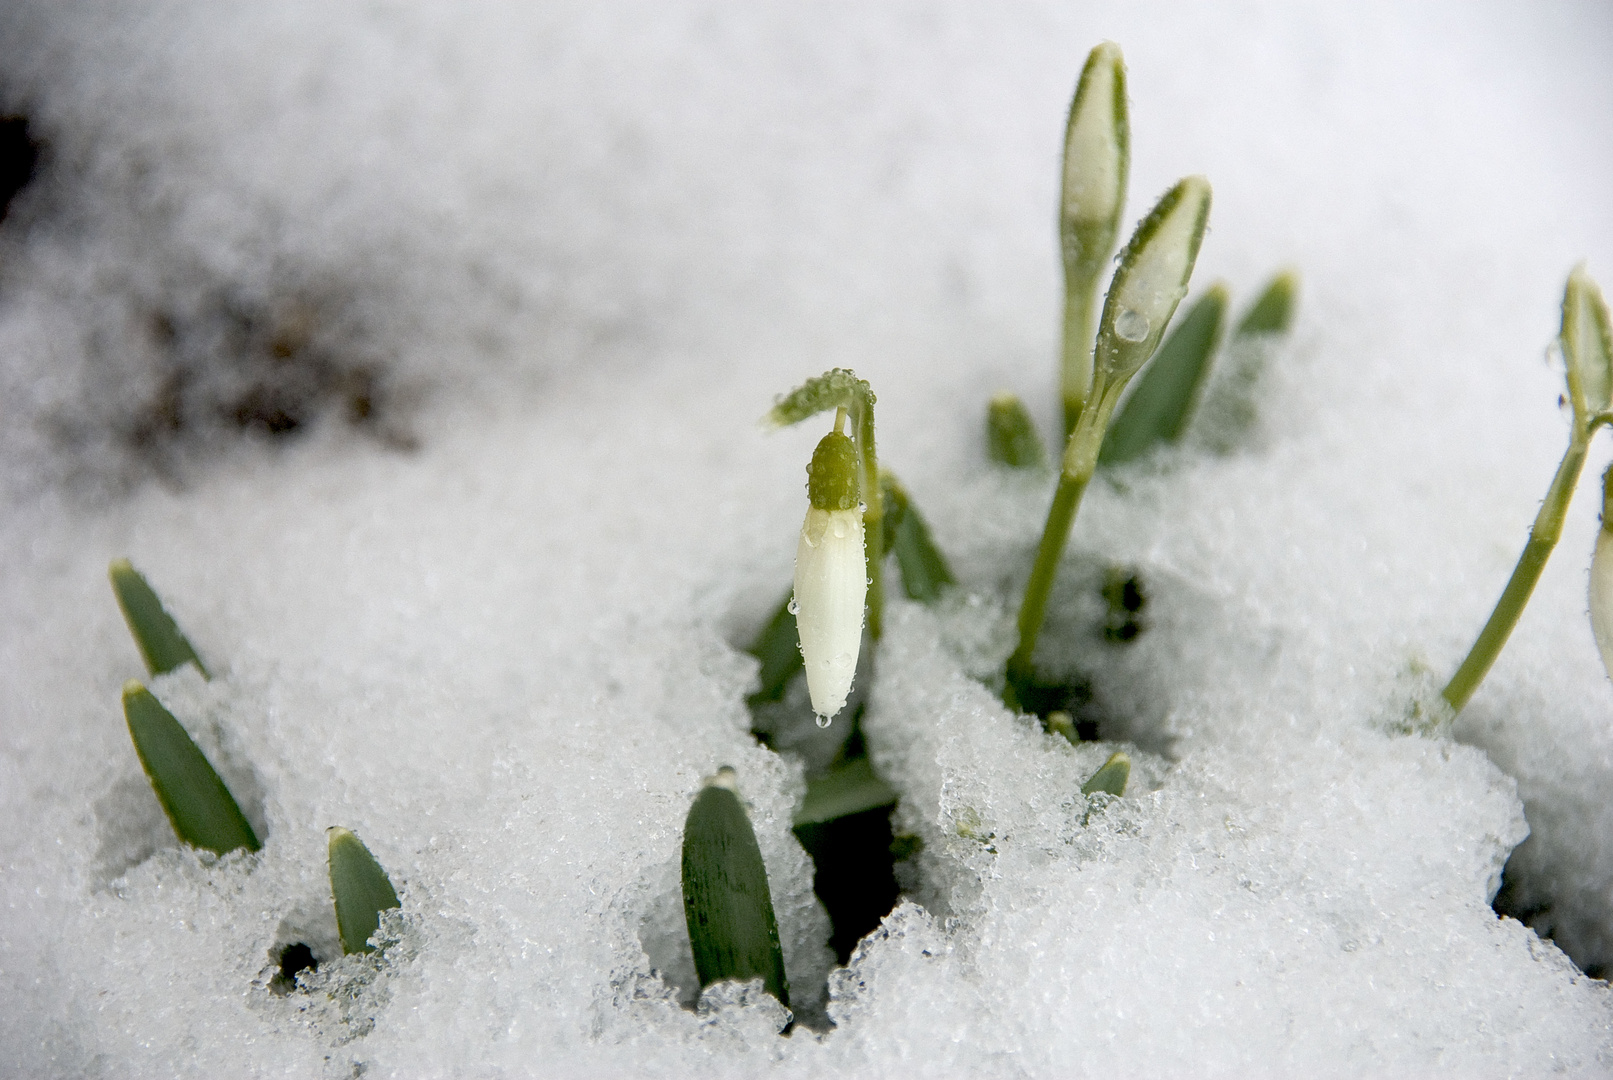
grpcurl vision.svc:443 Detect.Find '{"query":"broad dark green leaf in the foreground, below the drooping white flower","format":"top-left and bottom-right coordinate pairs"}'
top-left (684, 766), bottom-right (790, 1007)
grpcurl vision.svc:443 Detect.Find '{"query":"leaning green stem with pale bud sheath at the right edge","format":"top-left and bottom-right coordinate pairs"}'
top-left (1440, 266), bottom-right (1613, 714)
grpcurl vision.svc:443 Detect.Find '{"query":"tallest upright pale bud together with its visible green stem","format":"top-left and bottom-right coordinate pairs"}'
top-left (1058, 42), bottom-right (1131, 437)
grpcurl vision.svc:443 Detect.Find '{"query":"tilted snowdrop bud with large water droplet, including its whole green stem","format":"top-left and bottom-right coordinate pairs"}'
top-left (1003, 176), bottom-right (1210, 708)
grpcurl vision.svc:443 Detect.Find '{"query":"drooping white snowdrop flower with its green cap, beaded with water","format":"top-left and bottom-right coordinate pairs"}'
top-left (794, 409), bottom-right (868, 727)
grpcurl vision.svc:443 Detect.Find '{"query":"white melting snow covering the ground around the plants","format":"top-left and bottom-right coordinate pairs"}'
top-left (0, 0), bottom-right (1613, 1077)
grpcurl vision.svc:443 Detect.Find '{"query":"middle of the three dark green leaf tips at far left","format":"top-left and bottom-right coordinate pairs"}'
top-left (123, 679), bottom-right (263, 854)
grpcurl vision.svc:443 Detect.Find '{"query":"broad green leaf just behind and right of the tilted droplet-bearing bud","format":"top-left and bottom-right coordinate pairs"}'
top-left (1098, 285), bottom-right (1227, 466)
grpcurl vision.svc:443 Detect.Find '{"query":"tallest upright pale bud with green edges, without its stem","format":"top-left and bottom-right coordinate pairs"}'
top-left (1060, 42), bottom-right (1131, 277)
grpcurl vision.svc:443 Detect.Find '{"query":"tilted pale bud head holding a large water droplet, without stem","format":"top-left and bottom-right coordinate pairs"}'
top-left (1097, 176), bottom-right (1210, 385)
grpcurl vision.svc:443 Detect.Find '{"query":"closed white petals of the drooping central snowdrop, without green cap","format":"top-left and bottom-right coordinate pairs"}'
top-left (795, 508), bottom-right (868, 716)
